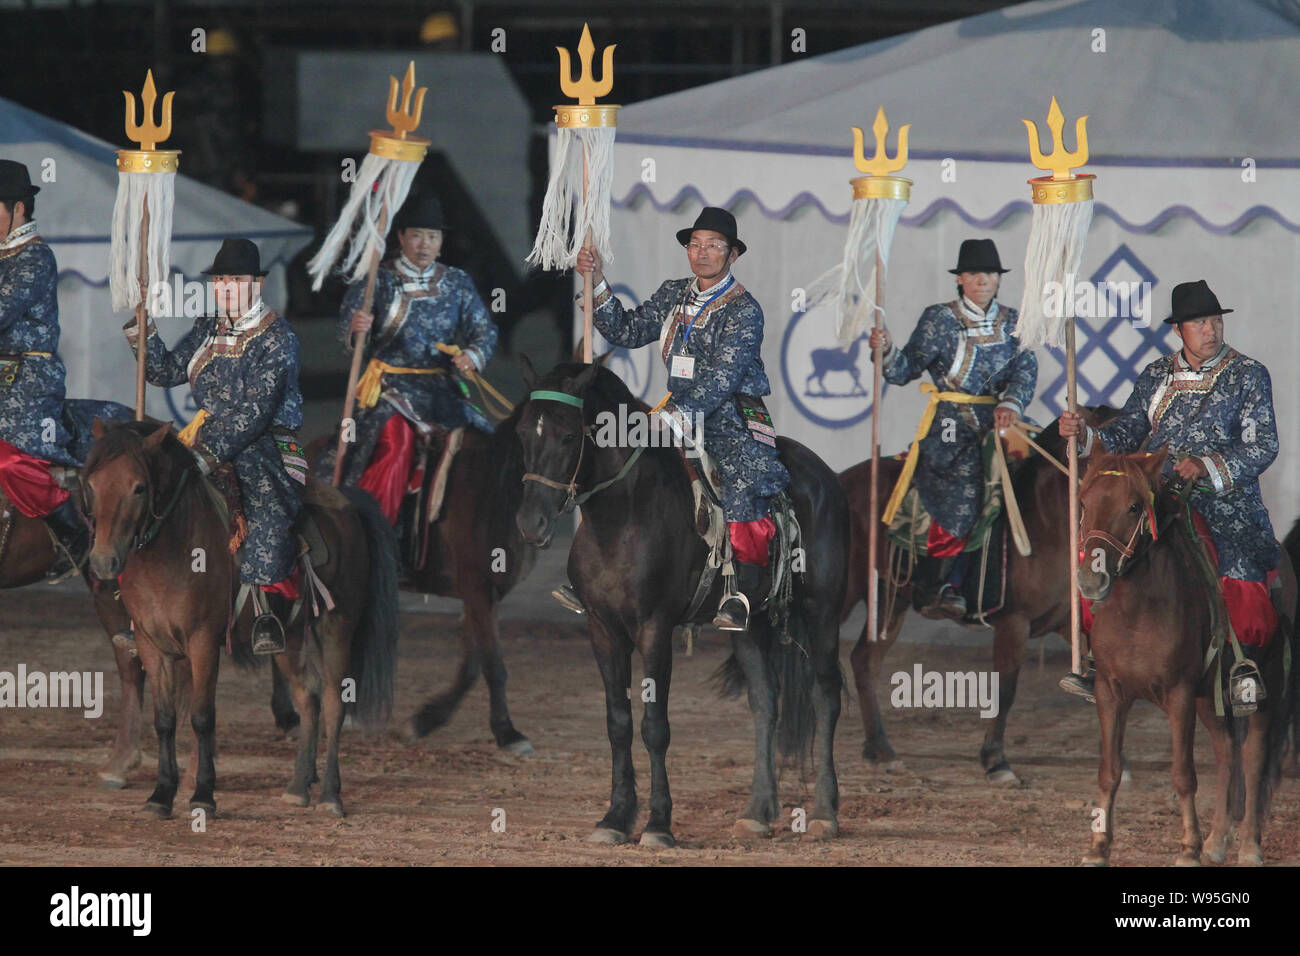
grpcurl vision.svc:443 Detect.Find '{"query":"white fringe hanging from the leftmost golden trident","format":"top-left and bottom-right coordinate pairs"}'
top-left (108, 173), bottom-right (176, 316)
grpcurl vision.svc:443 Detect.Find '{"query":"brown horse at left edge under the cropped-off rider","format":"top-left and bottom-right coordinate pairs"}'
top-left (0, 494), bottom-right (144, 788)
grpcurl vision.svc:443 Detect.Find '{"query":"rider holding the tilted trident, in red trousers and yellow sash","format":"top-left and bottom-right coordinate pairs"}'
top-left (316, 193), bottom-right (497, 525)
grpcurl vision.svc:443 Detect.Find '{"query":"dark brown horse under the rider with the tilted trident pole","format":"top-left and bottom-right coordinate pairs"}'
top-left (308, 395), bottom-right (537, 756)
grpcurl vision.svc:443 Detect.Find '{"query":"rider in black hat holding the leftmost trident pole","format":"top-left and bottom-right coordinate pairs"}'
top-left (124, 239), bottom-right (307, 654)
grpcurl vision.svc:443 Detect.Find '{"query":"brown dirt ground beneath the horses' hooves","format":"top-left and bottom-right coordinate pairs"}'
top-left (0, 588), bottom-right (1300, 866)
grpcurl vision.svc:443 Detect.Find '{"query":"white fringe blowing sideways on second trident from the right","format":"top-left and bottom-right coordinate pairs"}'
top-left (806, 199), bottom-right (907, 349)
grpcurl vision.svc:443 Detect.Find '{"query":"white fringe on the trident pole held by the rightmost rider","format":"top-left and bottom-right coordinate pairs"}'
top-left (1015, 199), bottom-right (1093, 349)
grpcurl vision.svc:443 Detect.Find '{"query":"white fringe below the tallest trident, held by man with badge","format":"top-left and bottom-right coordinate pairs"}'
top-left (525, 126), bottom-right (618, 269)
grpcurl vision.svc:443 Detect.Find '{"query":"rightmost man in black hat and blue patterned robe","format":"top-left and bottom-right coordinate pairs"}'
top-left (1061, 280), bottom-right (1282, 700)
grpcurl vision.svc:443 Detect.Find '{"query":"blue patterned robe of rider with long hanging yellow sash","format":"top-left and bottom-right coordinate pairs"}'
top-left (881, 299), bottom-right (1039, 538)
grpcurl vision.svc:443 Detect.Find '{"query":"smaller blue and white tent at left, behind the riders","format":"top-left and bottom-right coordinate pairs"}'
top-left (0, 99), bottom-right (312, 424)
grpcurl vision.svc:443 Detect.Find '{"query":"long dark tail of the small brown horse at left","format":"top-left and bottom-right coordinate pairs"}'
top-left (342, 488), bottom-right (398, 728)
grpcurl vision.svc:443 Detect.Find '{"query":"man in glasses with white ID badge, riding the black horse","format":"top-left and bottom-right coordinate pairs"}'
top-left (566, 206), bottom-right (790, 631)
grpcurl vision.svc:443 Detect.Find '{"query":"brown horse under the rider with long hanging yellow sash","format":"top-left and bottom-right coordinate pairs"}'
top-left (840, 407), bottom-right (1114, 784)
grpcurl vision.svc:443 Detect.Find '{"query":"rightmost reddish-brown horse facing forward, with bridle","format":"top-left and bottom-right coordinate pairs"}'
top-left (1078, 447), bottom-right (1296, 866)
